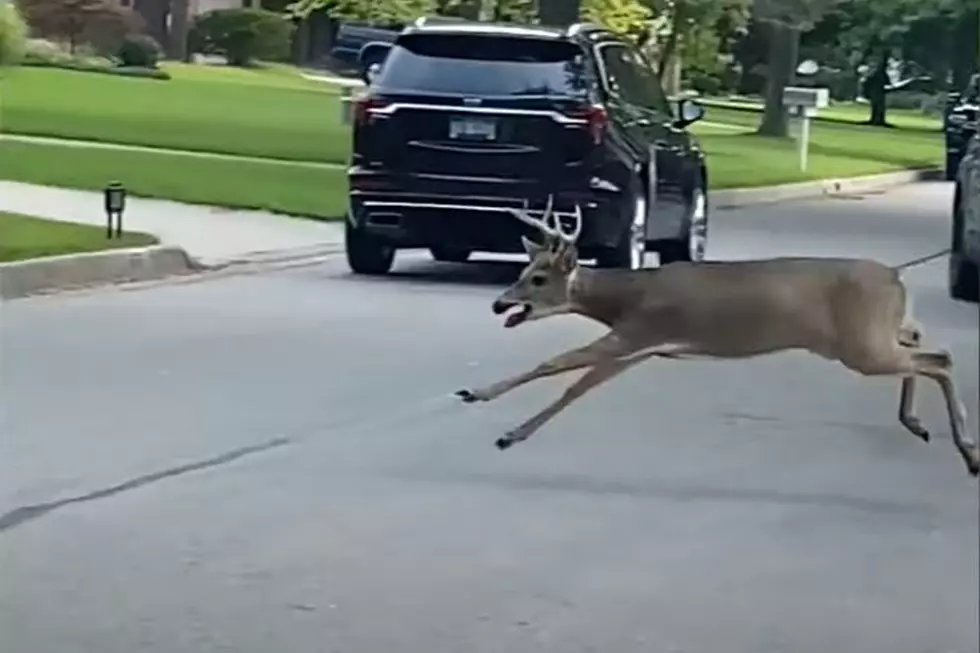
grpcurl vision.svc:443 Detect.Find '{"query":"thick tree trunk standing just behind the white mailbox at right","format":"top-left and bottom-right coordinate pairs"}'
top-left (753, 0), bottom-right (838, 138)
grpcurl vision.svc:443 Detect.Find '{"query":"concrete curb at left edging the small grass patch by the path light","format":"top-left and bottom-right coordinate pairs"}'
top-left (0, 245), bottom-right (209, 300)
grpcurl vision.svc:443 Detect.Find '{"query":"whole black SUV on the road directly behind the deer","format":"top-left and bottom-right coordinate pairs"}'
top-left (346, 19), bottom-right (708, 274)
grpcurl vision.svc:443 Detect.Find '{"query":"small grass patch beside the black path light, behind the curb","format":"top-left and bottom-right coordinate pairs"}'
top-left (0, 213), bottom-right (157, 262)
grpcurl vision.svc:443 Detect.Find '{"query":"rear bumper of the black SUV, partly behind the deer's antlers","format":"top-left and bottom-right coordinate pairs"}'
top-left (348, 166), bottom-right (625, 253)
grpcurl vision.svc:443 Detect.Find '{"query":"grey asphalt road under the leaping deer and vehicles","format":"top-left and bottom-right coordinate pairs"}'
top-left (0, 184), bottom-right (978, 653)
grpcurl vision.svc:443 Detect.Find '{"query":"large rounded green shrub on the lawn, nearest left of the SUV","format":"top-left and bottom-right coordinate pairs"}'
top-left (189, 9), bottom-right (295, 66)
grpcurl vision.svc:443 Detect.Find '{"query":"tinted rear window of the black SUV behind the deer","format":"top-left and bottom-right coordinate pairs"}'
top-left (376, 34), bottom-right (588, 97)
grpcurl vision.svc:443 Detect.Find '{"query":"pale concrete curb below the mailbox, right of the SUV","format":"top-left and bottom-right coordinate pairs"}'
top-left (710, 168), bottom-right (942, 209)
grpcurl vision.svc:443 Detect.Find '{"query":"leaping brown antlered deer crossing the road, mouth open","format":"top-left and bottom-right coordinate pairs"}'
top-left (455, 196), bottom-right (980, 477)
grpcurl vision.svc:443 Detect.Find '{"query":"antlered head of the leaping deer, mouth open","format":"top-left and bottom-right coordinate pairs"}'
top-left (493, 192), bottom-right (582, 328)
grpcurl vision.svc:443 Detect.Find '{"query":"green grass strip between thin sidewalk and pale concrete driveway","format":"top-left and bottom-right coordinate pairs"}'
top-left (0, 141), bottom-right (347, 217)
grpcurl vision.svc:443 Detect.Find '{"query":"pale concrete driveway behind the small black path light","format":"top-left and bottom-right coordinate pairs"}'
top-left (0, 181), bottom-right (343, 265)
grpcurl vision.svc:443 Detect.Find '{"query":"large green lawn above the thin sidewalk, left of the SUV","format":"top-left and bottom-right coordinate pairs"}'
top-left (0, 64), bottom-right (348, 162)
